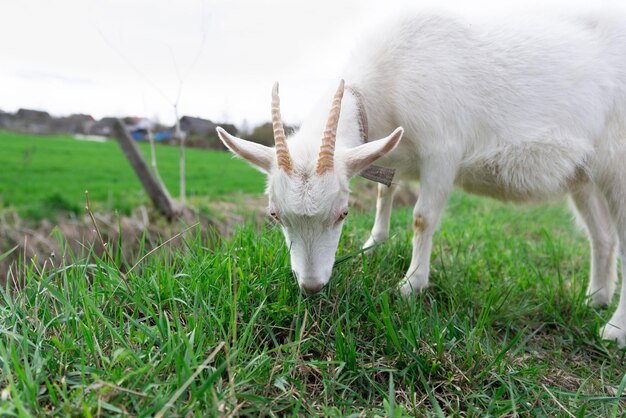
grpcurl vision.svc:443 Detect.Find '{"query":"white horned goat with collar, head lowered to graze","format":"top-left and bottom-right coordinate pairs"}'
top-left (218, 14), bottom-right (626, 346)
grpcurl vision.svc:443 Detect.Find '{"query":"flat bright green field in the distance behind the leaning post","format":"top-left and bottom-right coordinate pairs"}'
top-left (0, 131), bottom-right (263, 220)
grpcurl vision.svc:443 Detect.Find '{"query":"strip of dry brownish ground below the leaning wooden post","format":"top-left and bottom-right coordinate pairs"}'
top-left (0, 207), bottom-right (210, 285)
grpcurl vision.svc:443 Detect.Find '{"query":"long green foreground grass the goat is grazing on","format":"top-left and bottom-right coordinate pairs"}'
top-left (0, 194), bottom-right (626, 417)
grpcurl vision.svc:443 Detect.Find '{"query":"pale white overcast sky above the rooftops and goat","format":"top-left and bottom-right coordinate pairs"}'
top-left (0, 0), bottom-right (624, 130)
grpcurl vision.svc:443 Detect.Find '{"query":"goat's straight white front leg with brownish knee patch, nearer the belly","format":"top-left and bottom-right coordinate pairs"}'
top-left (400, 159), bottom-right (456, 295)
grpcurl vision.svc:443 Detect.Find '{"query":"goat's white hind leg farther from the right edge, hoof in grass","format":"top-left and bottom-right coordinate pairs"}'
top-left (572, 183), bottom-right (617, 306)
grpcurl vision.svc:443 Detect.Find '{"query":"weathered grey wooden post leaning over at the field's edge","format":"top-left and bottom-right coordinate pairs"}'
top-left (111, 119), bottom-right (182, 220)
